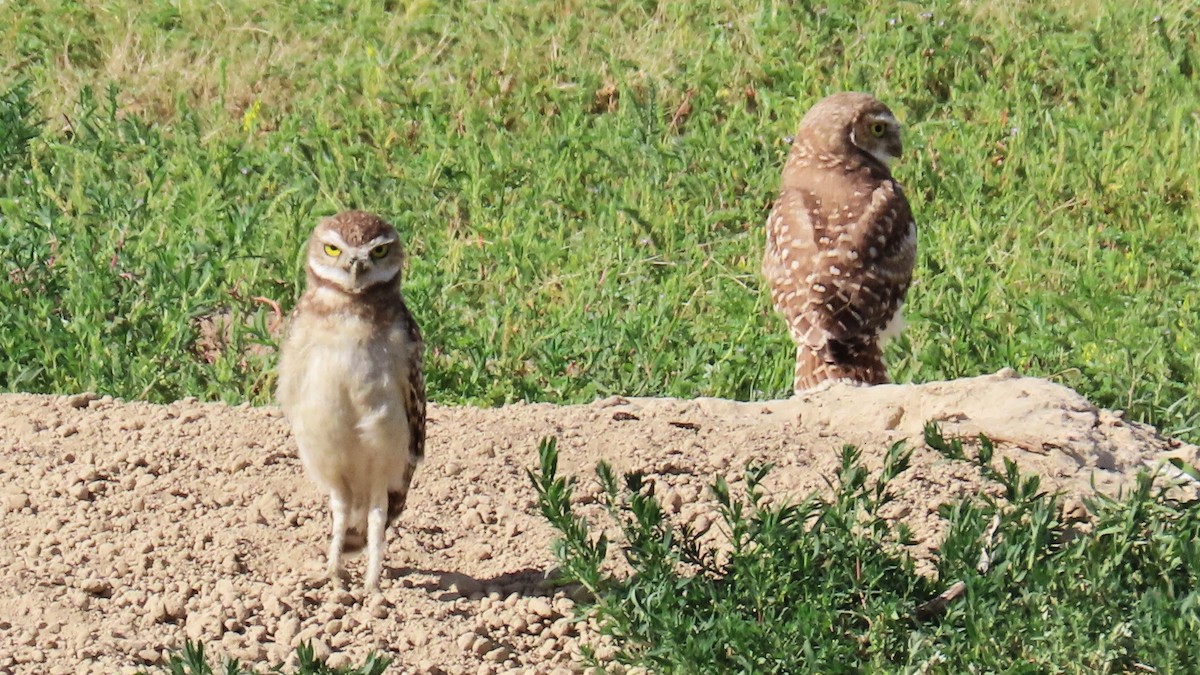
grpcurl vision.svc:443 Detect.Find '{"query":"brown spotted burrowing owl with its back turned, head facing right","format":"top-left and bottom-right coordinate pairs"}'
top-left (762, 92), bottom-right (917, 393)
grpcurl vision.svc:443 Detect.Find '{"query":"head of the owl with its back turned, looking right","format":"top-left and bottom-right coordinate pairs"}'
top-left (800, 91), bottom-right (904, 167)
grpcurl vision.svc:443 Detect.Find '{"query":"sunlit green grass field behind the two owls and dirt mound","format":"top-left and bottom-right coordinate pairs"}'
top-left (0, 0), bottom-right (1200, 440)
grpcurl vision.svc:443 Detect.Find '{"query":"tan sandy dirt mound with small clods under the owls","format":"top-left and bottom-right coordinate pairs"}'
top-left (0, 372), bottom-right (1200, 673)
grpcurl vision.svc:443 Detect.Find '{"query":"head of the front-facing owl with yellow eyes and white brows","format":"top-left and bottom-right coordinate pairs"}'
top-left (307, 211), bottom-right (404, 295)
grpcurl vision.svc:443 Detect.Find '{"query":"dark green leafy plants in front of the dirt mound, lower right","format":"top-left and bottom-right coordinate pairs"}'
top-left (532, 430), bottom-right (1200, 673)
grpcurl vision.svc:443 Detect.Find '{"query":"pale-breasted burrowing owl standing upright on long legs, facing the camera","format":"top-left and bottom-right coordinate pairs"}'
top-left (278, 211), bottom-right (425, 589)
